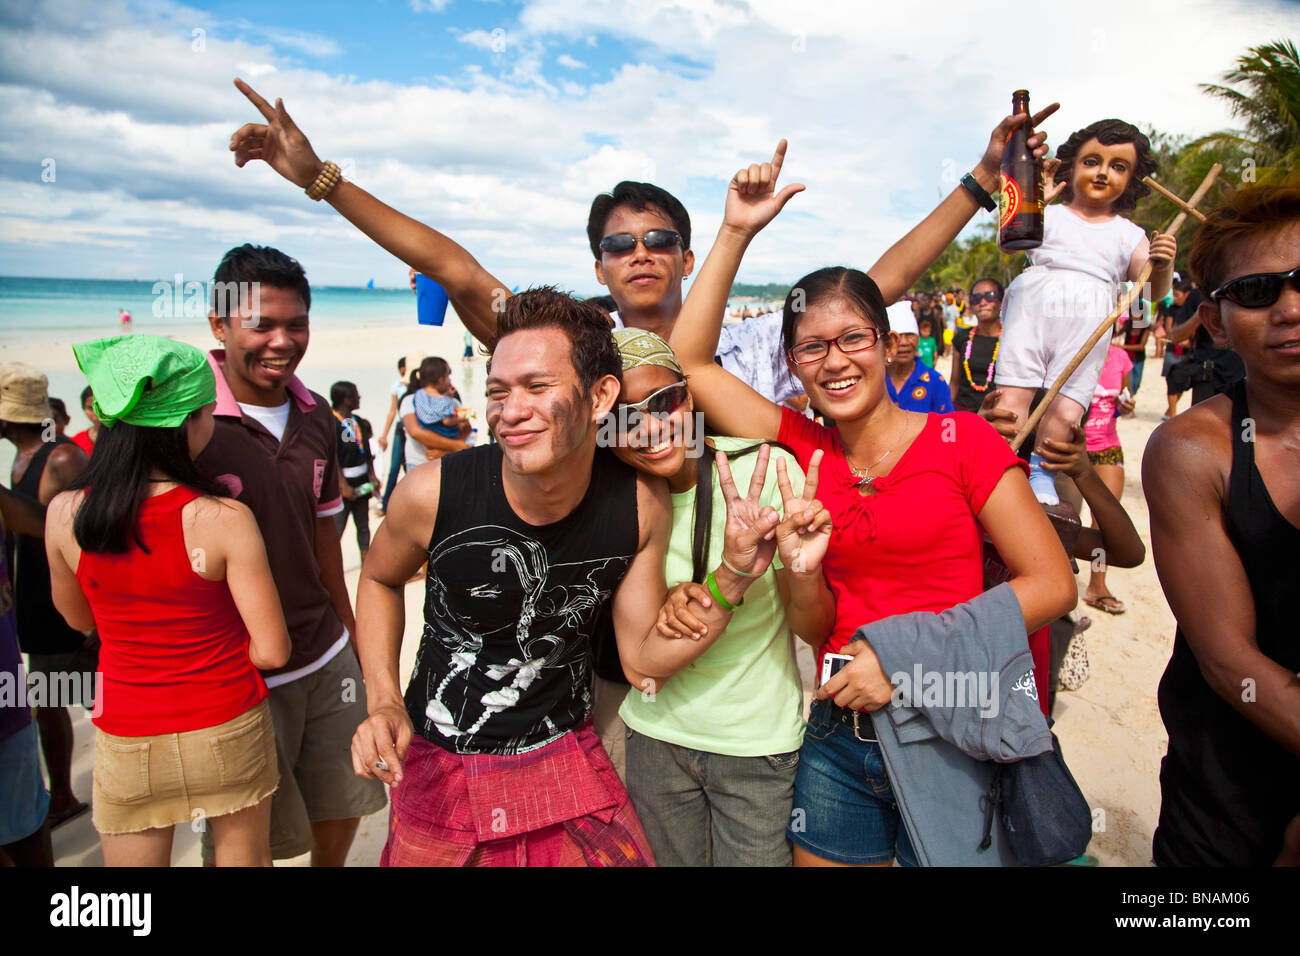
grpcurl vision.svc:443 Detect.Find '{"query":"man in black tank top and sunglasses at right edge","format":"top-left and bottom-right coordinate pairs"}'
top-left (1143, 186), bottom-right (1300, 866)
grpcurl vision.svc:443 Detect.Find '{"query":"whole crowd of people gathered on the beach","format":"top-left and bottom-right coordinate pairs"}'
top-left (0, 81), bottom-right (1300, 866)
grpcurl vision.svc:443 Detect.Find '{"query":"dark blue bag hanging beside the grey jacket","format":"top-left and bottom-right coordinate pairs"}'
top-left (980, 734), bottom-right (1092, 866)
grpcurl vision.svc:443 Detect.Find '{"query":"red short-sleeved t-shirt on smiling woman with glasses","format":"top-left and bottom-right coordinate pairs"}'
top-left (777, 408), bottom-right (1028, 670)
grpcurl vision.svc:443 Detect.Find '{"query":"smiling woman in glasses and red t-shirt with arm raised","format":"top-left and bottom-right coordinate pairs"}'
top-left (672, 141), bottom-right (1078, 865)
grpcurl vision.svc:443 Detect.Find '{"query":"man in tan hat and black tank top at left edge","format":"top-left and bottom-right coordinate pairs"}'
top-left (0, 363), bottom-right (98, 827)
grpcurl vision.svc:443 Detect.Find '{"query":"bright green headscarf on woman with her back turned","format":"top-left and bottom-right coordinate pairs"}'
top-left (73, 336), bottom-right (217, 428)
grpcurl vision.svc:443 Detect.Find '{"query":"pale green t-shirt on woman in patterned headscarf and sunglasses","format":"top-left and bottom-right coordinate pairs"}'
top-left (619, 437), bottom-right (803, 757)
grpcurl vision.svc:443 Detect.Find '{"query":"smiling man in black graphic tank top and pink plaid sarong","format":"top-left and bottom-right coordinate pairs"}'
top-left (352, 289), bottom-right (764, 865)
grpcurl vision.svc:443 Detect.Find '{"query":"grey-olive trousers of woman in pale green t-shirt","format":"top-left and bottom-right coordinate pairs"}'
top-left (627, 728), bottom-right (800, 866)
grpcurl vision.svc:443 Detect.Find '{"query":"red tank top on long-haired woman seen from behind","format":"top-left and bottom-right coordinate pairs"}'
top-left (77, 488), bottom-right (267, 737)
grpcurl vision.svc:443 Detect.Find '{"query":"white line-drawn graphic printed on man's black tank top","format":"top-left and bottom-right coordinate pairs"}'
top-left (406, 525), bottom-right (629, 754)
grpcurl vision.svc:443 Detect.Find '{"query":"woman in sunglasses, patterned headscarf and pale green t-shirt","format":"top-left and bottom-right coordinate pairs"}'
top-left (611, 329), bottom-right (835, 866)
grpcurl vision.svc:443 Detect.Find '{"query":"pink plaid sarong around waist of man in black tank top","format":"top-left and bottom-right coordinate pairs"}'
top-left (380, 721), bottom-right (654, 866)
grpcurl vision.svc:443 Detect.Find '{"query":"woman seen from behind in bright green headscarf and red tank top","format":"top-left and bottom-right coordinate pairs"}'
top-left (46, 336), bottom-right (289, 866)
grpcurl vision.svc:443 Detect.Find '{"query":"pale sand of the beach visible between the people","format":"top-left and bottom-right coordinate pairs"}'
top-left (0, 317), bottom-right (1187, 866)
